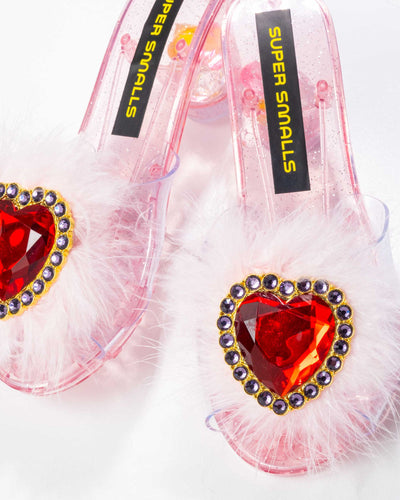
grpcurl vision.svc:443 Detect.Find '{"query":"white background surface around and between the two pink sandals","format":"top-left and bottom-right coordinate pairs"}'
top-left (0, 0), bottom-right (400, 500)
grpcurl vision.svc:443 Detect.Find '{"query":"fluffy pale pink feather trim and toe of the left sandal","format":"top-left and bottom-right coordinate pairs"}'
top-left (0, 136), bottom-right (162, 393)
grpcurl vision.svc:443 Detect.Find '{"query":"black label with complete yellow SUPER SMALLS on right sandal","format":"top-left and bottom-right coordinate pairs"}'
top-left (256, 10), bottom-right (310, 194)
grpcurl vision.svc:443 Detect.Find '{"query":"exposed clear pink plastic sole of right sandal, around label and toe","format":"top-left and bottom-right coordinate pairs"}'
top-left (213, 0), bottom-right (391, 474)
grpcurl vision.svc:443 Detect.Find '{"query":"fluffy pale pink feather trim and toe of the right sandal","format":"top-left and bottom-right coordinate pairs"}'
top-left (164, 181), bottom-right (400, 472)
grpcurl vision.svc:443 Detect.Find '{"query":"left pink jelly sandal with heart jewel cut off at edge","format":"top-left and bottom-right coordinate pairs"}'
top-left (0, 0), bottom-right (224, 394)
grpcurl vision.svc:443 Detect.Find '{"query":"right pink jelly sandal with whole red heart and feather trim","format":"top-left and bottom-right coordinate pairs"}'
top-left (165, 0), bottom-right (400, 474)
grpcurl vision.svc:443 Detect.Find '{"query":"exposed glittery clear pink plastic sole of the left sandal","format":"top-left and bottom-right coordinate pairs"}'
top-left (0, 0), bottom-right (221, 395)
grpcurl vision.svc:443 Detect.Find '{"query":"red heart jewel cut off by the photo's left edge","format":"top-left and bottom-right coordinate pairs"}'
top-left (0, 200), bottom-right (56, 300)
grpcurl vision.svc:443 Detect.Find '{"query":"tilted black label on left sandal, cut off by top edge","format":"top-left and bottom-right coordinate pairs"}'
top-left (112, 0), bottom-right (183, 137)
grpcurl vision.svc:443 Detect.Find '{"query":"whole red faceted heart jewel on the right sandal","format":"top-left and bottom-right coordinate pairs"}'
top-left (235, 292), bottom-right (335, 397)
